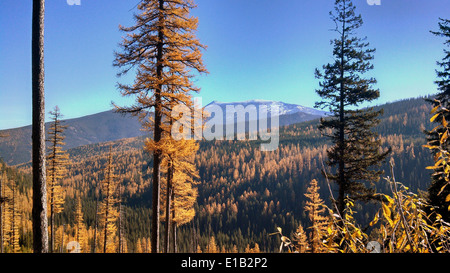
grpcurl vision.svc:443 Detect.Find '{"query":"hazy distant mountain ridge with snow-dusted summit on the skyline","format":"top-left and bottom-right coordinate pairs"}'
top-left (0, 100), bottom-right (326, 165)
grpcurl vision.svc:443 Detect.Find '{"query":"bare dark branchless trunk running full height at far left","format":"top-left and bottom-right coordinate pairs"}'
top-left (31, 0), bottom-right (48, 253)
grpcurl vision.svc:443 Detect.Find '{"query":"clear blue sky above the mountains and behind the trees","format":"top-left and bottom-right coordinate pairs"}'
top-left (0, 0), bottom-right (450, 129)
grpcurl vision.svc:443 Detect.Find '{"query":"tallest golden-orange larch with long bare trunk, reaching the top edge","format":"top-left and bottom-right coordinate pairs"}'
top-left (114, 0), bottom-right (206, 253)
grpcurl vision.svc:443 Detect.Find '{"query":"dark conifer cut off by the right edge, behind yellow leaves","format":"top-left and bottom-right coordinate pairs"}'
top-left (426, 19), bottom-right (450, 222)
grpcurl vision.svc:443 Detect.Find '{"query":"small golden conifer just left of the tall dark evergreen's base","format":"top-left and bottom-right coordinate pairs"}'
top-left (305, 179), bottom-right (328, 253)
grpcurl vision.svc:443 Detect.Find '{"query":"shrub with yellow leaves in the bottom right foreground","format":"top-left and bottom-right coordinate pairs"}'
top-left (370, 159), bottom-right (450, 253)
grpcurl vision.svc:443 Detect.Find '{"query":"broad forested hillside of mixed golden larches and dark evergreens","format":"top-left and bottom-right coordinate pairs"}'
top-left (2, 95), bottom-right (433, 252)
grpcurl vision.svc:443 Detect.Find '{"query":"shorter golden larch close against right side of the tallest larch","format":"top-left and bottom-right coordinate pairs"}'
top-left (160, 88), bottom-right (203, 252)
